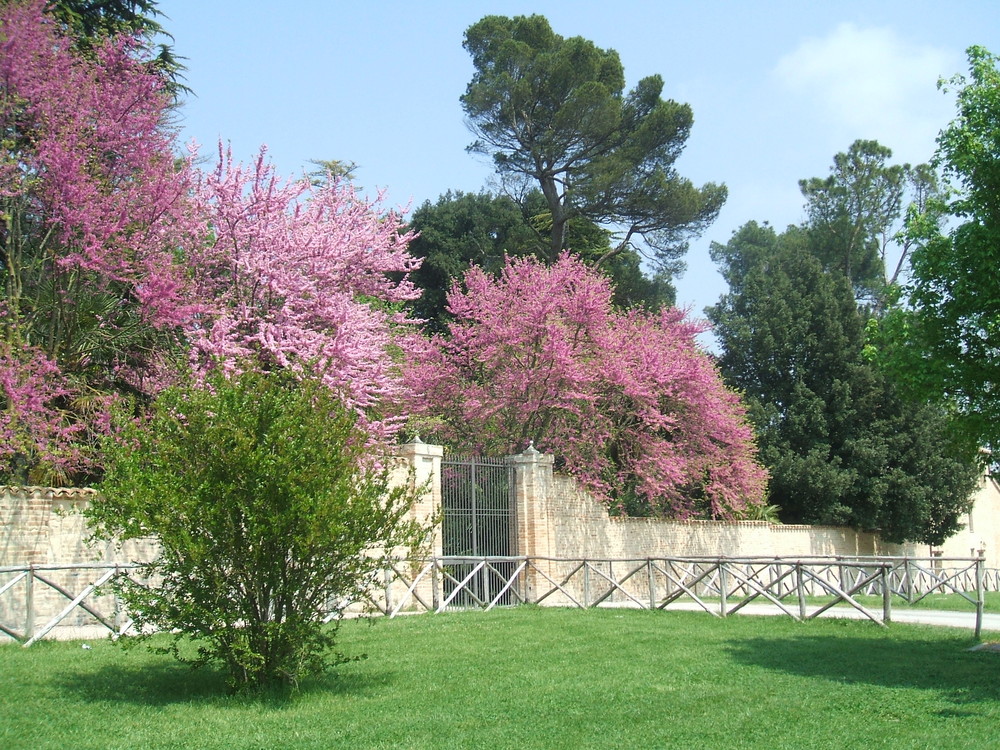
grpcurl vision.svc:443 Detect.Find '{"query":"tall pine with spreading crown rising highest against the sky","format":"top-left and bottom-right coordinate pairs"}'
top-left (462, 15), bottom-right (726, 273)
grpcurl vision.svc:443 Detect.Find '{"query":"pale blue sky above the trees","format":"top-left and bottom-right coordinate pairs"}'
top-left (159, 0), bottom-right (1000, 328)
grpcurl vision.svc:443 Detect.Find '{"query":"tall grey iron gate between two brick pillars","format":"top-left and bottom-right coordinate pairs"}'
top-left (441, 456), bottom-right (517, 607)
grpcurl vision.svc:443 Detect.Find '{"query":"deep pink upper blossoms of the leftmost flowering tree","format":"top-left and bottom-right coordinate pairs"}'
top-left (0, 1), bottom-right (198, 326)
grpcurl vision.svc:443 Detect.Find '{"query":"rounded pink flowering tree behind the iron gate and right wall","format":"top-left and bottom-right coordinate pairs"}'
top-left (408, 254), bottom-right (767, 518)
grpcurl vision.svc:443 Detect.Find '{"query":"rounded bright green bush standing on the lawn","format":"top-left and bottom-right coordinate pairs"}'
top-left (89, 370), bottom-right (419, 690)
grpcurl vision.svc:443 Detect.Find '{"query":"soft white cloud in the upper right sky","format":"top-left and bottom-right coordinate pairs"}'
top-left (774, 23), bottom-right (962, 162)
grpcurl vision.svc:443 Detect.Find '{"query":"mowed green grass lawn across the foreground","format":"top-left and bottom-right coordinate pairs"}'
top-left (0, 607), bottom-right (1000, 750)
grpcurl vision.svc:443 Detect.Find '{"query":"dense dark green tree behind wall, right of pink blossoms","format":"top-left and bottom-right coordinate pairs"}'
top-left (709, 222), bottom-right (976, 544)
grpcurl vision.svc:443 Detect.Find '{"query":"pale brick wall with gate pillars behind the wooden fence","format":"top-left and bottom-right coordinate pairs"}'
top-left (0, 443), bottom-right (1000, 640)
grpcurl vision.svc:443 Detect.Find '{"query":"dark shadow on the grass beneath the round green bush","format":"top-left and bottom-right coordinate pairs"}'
top-left (59, 658), bottom-right (393, 709)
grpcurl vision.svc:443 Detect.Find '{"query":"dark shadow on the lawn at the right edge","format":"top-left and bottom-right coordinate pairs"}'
top-left (727, 636), bottom-right (1000, 713)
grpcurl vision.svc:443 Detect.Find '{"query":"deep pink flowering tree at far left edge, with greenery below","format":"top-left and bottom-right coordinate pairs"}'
top-left (0, 0), bottom-right (199, 481)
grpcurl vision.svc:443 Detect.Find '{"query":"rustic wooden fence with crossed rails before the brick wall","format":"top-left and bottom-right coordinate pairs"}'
top-left (0, 557), bottom-right (1000, 646)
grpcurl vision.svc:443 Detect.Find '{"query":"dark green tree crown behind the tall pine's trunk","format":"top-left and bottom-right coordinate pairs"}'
top-left (409, 190), bottom-right (674, 331)
